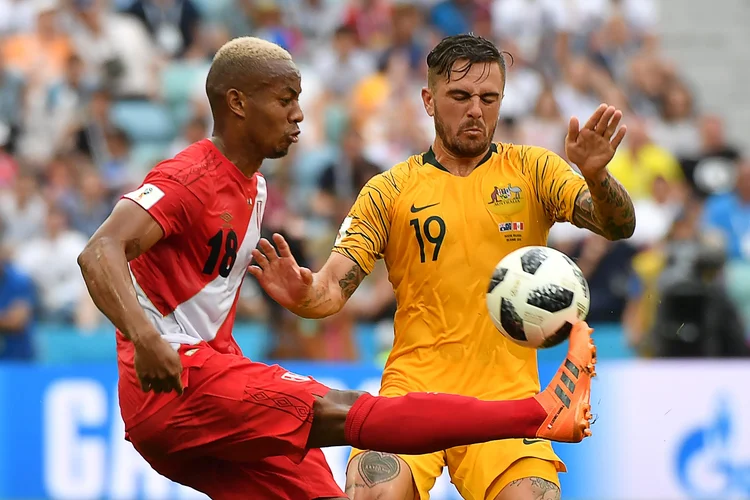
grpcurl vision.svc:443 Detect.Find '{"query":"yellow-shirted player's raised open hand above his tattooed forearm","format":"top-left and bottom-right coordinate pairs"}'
top-left (565, 104), bottom-right (627, 180)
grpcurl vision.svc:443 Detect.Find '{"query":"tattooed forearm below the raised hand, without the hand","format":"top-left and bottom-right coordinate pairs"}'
top-left (572, 175), bottom-right (635, 240)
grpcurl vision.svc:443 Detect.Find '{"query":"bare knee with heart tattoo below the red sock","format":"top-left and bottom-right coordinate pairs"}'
top-left (346, 451), bottom-right (418, 500)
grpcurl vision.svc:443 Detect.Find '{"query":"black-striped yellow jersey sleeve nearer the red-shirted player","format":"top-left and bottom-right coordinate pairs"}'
top-left (333, 167), bottom-right (401, 274)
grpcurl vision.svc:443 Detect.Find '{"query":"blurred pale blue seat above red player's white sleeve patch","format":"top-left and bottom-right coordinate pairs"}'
top-left (110, 101), bottom-right (176, 142)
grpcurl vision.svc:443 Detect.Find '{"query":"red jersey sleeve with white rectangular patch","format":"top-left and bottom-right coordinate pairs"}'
top-left (122, 162), bottom-right (204, 238)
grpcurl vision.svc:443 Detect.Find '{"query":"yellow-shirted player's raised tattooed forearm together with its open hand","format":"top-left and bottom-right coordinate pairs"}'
top-left (565, 104), bottom-right (635, 240)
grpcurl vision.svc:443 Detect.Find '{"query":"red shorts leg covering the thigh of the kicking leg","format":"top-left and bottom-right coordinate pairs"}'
top-left (129, 348), bottom-right (329, 462)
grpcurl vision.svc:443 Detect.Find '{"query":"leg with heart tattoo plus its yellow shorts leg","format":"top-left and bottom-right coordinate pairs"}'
top-left (346, 449), bottom-right (445, 500)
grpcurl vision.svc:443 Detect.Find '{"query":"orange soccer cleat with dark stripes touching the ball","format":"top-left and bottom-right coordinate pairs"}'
top-left (534, 321), bottom-right (596, 443)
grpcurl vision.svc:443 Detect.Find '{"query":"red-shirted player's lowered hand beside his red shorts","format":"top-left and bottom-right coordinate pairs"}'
top-left (135, 335), bottom-right (182, 394)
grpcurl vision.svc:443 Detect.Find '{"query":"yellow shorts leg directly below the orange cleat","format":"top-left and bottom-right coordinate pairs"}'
top-left (446, 439), bottom-right (565, 500)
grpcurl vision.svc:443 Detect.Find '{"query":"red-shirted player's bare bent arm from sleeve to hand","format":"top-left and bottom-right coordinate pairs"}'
top-left (78, 200), bottom-right (182, 393)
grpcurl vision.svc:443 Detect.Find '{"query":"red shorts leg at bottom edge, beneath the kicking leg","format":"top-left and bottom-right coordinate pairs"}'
top-left (146, 450), bottom-right (346, 500)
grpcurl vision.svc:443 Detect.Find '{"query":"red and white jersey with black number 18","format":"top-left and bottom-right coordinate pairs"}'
top-left (118, 139), bottom-right (266, 359)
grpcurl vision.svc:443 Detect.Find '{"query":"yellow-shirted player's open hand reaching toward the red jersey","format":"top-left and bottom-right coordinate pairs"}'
top-left (248, 234), bottom-right (313, 308)
